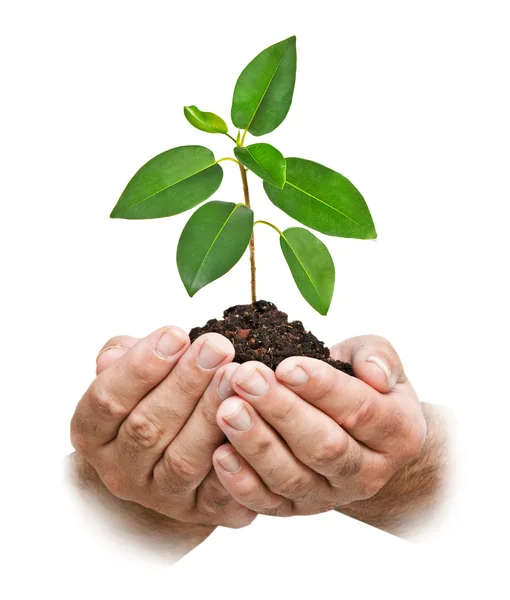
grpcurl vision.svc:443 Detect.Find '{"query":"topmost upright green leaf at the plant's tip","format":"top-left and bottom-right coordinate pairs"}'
top-left (231, 36), bottom-right (296, 136)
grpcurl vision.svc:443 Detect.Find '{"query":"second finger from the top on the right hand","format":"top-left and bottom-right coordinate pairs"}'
top-left (229, 362), bottom-right (369, 482)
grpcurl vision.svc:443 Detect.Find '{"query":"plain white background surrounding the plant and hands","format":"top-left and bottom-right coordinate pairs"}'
top-left (0, 0), bottom-right (510, 599)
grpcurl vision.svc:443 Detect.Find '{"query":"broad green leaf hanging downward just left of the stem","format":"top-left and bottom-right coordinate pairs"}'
top-left (177, 201), bottom-right (253, 296)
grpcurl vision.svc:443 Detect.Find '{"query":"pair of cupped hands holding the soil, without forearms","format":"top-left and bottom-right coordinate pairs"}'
top-left (71, 327), bottom-right (426, 527)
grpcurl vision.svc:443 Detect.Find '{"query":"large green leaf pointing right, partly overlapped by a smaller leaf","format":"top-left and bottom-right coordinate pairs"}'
top-left (264, 158), bottom-right (377, 239)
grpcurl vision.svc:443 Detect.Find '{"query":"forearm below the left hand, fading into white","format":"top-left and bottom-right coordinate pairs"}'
top-left (68, 453), bottom-right (215, 562)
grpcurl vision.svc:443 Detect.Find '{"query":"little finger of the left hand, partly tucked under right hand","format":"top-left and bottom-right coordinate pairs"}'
top-left (192, 466), bottom-right (257, 529)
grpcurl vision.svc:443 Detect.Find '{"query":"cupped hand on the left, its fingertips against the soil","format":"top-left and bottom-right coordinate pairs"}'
top-left (71, 327), bottom-right (256, 527)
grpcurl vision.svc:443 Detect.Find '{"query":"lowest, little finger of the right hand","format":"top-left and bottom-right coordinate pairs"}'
top-left (213, 444), bottom-right (293, 517)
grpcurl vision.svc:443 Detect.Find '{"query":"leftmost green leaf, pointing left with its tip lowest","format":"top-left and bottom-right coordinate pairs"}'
top-left (110, 146), bottom-right (223, 219)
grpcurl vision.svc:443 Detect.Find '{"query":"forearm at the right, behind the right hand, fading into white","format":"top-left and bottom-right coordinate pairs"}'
top-left (338, 404), bottom-right (450, 537)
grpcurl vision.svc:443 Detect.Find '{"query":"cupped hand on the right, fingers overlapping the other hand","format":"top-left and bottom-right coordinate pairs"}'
top-left (213, 336), bottom-right (427, 516)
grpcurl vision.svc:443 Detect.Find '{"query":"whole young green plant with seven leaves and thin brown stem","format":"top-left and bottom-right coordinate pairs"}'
top-left (110, 37), bottom-right (377, 315)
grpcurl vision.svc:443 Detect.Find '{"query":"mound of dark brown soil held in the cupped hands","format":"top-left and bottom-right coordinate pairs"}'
top-left (189, 300), bottom-right (354, 376)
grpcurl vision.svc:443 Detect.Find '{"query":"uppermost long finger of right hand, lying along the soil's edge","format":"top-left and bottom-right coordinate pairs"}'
top-left (276, 356), bottom-right (420, 452)
